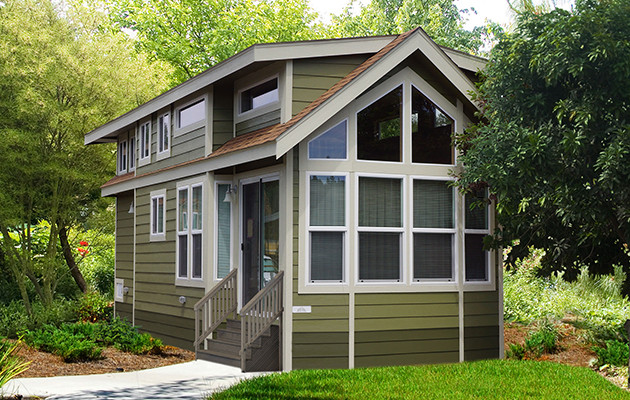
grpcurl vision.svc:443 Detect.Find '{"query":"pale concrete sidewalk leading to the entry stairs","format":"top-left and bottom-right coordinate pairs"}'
top-left (0, 360), bottom-right (260, 399)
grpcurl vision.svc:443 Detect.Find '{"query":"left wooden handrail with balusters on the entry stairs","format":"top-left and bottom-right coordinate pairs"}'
top-left (194, 269), bottom-right (238, 356)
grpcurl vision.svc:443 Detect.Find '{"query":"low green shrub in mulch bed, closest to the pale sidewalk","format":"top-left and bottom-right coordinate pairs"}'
top-left (24, 323), bottom-right (102, 362)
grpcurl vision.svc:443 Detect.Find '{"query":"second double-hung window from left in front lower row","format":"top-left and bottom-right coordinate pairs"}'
top-left (358, 176), bottom-right (404, 282)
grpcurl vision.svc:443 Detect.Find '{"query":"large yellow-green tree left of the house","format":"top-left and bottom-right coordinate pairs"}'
top-left (0, 0), bottom-right (168, 309)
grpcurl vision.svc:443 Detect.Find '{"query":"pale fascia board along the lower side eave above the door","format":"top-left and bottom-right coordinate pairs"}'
top-left (101, 142), bottom-right (276, 197)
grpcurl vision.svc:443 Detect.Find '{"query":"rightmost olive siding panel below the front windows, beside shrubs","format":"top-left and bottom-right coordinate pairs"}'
top-left (464, 291), bottom-right (499, 361)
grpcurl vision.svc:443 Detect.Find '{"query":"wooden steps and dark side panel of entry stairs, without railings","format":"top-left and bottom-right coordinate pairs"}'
top-left (197, 318), bottom-right (280, 372)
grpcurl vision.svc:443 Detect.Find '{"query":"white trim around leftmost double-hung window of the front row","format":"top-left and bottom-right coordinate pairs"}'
top-left (304, 171), bottom-right (350, 286)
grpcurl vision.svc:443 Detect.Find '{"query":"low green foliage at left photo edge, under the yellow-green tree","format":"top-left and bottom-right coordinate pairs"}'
top-left (0, 299), bottom-right (77, 338)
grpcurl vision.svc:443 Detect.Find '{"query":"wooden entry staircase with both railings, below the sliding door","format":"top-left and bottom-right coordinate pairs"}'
top-left (194, 270), bottom-right (284, 372)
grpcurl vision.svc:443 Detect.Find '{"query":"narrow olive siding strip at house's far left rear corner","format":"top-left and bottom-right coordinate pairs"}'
top-left (116, 192), bottom-right (134, 321)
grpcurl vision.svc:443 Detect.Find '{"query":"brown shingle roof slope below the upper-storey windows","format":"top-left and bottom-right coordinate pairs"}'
top-left (101, 28), bottom-right (420, 187)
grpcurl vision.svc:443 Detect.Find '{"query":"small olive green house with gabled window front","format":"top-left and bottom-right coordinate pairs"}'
top-left (85, 29), bottom-right (503, 371)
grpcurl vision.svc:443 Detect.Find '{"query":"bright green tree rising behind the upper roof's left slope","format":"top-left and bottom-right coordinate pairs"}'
top-left (111, 0), bottom-right (322, 84)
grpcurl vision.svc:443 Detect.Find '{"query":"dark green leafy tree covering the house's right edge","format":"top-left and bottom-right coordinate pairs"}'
top-left (457, 0), bottom-right (630, 276)
